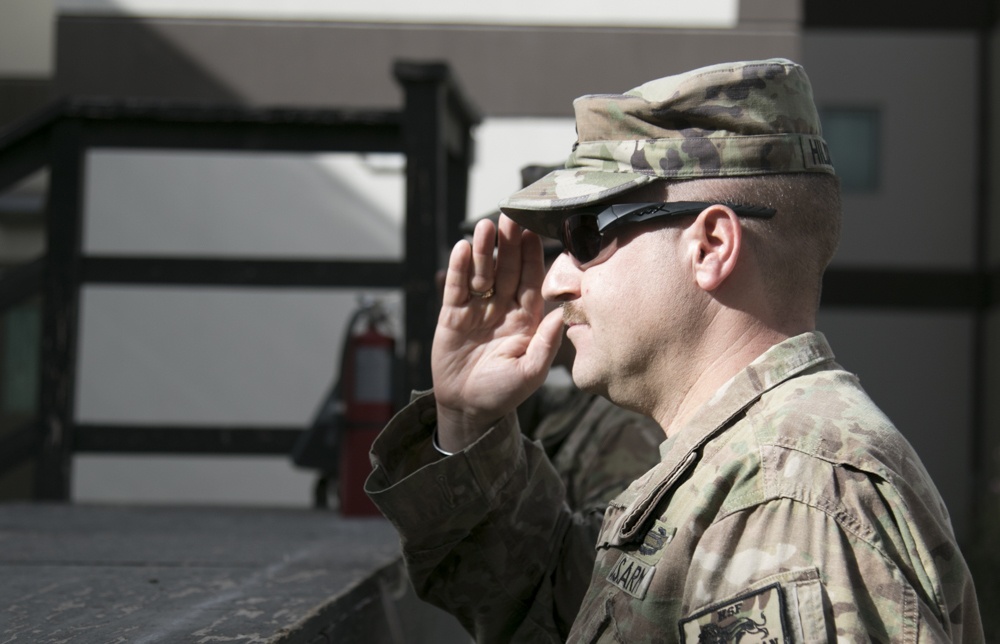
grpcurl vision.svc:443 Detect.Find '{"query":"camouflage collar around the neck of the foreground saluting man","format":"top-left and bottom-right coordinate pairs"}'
top-left (601, 332), bottom-right (833, 545)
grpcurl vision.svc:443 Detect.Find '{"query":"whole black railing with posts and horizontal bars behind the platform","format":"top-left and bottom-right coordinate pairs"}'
top-left (0, 62), bottom-right (479, 500)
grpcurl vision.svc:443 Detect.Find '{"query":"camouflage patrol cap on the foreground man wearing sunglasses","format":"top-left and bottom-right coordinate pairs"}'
top-left (500, 58), bottom-right (833, 237)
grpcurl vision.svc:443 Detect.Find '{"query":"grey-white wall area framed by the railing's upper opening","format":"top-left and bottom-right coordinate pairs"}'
top-left (84, 150), bottom-right (405, 259)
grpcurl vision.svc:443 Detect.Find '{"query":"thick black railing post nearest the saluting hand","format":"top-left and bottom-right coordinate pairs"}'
top-left (393, 62), bottom-right (474, 396)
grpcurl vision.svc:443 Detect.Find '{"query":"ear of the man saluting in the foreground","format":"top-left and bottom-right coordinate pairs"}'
top-left (688, 204), bottom-right (743, 292)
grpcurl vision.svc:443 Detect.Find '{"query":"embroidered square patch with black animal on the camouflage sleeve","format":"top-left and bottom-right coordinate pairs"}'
top-left (678, 584), bottom-right (792, 644)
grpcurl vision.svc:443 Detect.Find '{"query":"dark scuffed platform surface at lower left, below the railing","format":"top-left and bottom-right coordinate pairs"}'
top-left (0, 504), bottom-right (404, 644)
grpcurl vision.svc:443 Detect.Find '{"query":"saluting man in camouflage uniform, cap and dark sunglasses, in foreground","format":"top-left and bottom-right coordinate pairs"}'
top-left (367, 59), bottom-right (983, 644)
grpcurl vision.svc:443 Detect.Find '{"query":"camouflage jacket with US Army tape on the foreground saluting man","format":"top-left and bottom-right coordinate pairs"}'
top-left (369, 333), bottom-right (983, 644)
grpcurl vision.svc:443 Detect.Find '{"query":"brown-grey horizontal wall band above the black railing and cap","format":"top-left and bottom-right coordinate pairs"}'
top-left (57, 0), bottom-right (799, 116)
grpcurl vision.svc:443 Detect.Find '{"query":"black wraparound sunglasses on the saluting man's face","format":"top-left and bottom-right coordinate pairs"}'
top-left (559, 201), bottom-right (775, 265)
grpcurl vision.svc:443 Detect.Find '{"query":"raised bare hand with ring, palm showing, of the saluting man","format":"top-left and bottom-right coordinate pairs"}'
top-left (431, 216), bottom-right (562, 452)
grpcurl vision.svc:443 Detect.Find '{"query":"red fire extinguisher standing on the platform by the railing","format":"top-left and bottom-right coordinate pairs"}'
top-left (337, 302), bottom-right (396, 516)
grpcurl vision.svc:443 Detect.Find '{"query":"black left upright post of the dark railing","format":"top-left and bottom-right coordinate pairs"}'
top-left (35, 119), bottom-right (84, 501)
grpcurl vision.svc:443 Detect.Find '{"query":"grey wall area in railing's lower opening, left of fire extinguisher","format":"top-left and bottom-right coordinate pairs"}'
top-left (76, 286), bottom-right (400, 427)
